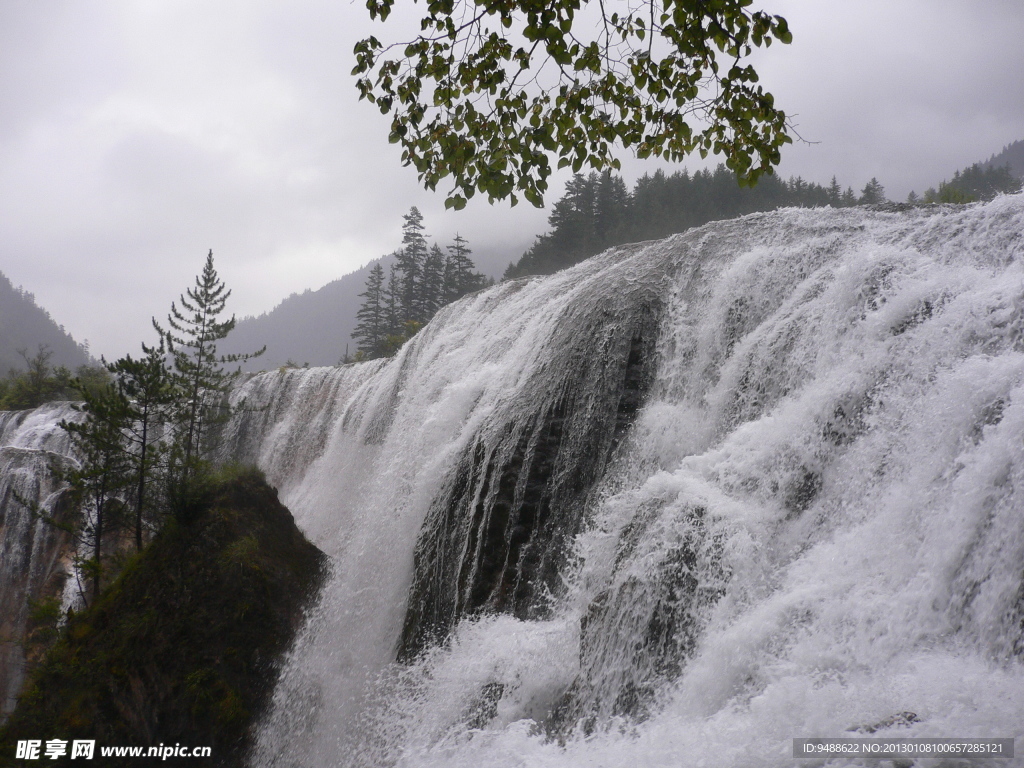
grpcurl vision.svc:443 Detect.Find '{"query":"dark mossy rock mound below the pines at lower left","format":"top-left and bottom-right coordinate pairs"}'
top-left (0, 470), bottom-right (326, 766)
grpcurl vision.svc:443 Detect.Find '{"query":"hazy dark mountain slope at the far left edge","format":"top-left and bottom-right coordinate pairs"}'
top-left (0, 272), bottom-right (90, 377)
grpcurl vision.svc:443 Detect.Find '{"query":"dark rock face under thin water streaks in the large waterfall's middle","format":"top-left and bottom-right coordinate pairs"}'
top-left (398, 301), bottom-right (659, 658)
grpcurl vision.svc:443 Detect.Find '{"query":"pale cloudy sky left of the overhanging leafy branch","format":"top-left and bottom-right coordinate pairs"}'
top-left (0, 0), bottom-right (544, 355)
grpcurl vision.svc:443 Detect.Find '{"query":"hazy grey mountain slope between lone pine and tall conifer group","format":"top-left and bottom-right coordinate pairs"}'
top-left (218, 256), bottom-right (392, 371)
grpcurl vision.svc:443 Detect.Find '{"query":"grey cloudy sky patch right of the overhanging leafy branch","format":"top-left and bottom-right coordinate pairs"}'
top-left (759, 0), bottom-right (1024, 198)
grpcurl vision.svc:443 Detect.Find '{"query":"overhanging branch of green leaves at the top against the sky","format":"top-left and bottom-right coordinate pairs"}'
top-left (352, 0), bottom-right (792, 209)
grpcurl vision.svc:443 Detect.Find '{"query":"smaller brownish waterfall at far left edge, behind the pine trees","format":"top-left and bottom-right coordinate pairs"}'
top-left (0, 402), bottom-right (77, 719)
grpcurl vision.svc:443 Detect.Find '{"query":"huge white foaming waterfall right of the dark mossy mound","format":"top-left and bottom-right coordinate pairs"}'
top-left (2, 196), bottom-right (1024, 768)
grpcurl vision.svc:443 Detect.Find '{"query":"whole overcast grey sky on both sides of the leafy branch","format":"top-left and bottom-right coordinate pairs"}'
top-left (0, 0), bottom-right (1024, 357)
